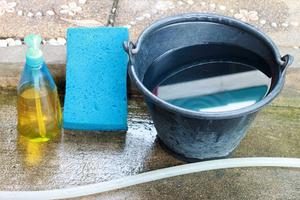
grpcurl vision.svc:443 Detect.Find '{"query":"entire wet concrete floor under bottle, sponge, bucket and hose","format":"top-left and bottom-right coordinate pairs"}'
top-left (0, 85), bottom-right (300, 193)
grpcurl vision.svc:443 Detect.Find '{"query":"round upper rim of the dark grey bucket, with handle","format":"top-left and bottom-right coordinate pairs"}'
top-left (128, 13), bottom-right (290, 119)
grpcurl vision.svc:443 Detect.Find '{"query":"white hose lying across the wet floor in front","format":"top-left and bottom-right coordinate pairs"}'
top-left (0, 157), bottom-right (300, 199)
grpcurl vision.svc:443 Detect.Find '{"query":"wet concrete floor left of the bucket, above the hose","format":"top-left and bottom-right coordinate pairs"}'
top-left (0, 94), bottom-right (182, 190)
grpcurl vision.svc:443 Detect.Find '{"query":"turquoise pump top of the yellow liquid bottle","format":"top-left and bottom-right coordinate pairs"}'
top-left (24, 34), bottom-right (44, 68)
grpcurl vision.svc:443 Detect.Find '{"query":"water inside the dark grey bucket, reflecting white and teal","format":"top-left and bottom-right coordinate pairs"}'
top-left (151, 46), bottom-right (271, 112)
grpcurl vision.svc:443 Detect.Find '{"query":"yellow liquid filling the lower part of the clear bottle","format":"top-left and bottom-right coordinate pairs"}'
top-left (17, 87), bottom-right (62, 142)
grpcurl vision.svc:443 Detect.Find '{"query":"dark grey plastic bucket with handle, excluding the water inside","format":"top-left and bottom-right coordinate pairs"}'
top-left (125, 13), bottom-right (292, 161)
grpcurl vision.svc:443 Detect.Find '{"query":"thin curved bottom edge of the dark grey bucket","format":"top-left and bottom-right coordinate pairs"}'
top-left (156, 136), bottom-right (233, 163)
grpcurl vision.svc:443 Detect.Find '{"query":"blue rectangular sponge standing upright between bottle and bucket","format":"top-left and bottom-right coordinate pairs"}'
top-left (63, 27), bottom-right (128, 131)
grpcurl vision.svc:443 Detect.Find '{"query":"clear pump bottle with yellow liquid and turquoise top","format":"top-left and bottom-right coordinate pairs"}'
top-left (17, 34), bottom-right (62, 142)
